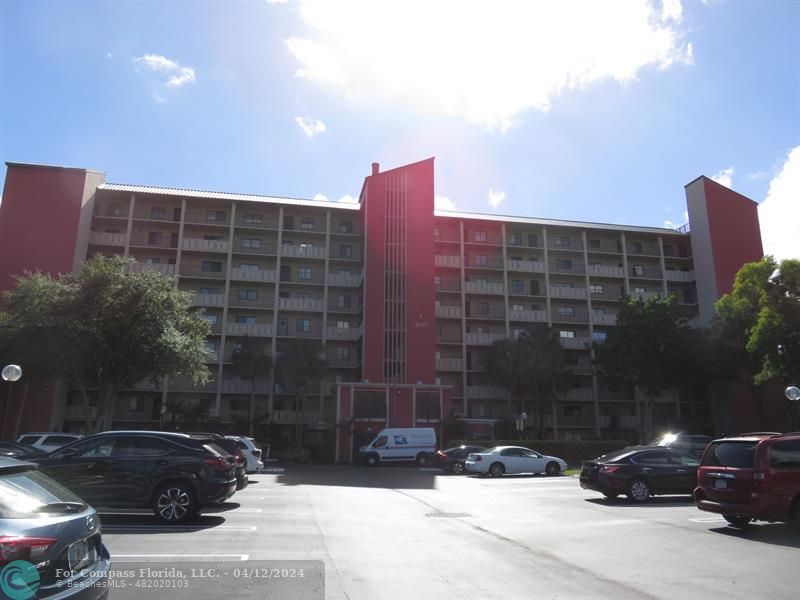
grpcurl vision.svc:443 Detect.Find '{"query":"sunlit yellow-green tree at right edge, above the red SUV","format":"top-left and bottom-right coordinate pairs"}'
top-left (715, 256), bottom-right (800, 424)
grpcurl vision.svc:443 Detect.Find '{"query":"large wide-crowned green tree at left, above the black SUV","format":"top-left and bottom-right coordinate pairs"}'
top-left (0, 255), bottom-right (210, 431)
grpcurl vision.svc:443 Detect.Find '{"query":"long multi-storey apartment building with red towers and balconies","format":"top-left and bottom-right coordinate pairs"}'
top-left (0, 159), bottom-right (762, 460)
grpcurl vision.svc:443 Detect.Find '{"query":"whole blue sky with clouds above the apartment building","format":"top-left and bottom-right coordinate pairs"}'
top-left (0, 0), bottom-right (800, 258)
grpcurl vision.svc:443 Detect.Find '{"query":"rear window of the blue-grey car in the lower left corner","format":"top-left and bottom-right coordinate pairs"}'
top-left (0, 469), bottom-right (87, 519)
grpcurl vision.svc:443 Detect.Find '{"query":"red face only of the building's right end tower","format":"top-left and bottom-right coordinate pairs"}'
top-left (703, 179), bottom-right (764, 296)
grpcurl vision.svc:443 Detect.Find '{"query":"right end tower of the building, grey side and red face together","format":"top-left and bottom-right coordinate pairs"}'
top-left (686, 175), bottom-right (764, 325)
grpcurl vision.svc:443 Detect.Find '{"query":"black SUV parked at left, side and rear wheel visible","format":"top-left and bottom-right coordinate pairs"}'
top-left (29, 431), bottom-right (236, 523)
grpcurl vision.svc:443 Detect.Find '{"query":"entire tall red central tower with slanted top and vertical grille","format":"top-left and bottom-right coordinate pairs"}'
top-left (361, 158), bottom-right (436, 384)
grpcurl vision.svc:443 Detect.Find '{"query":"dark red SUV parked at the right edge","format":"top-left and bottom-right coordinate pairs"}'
top-left (694, 432), bottom-right (800, 530)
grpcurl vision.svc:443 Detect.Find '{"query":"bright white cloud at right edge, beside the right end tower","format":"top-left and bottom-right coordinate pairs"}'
top-left (758, 146), bottom-right (800, 260)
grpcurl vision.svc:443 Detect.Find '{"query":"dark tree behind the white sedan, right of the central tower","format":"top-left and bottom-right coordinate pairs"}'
top-left (482, 328), bottom-right (570, 437)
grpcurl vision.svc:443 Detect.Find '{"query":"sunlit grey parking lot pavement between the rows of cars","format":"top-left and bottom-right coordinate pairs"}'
top-left (103, 465), bottom-right (800, 600)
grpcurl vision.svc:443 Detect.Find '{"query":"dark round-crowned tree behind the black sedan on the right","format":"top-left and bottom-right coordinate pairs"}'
top-left (594, 296), bottom-right (690, 440)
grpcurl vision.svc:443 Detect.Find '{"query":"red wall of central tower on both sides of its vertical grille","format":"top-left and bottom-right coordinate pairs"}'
top-left (362, 158), bottom-right (436, 384)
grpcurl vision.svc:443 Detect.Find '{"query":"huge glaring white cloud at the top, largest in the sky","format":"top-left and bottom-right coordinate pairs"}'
top-left (286, 0), bottom-right (694, 130)
